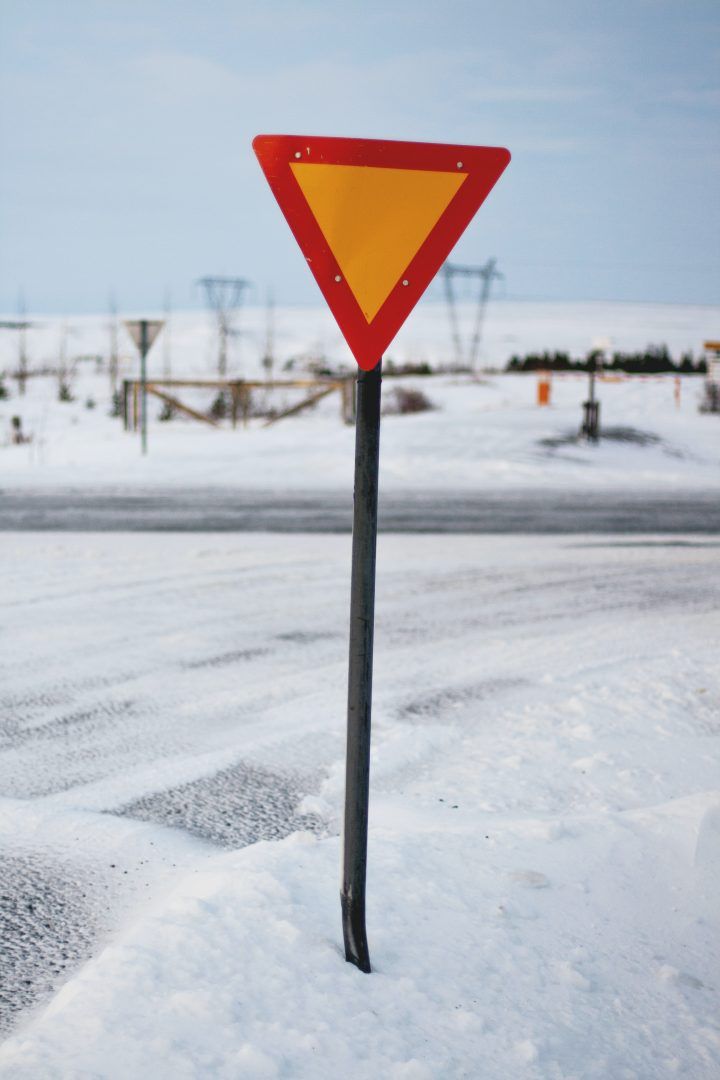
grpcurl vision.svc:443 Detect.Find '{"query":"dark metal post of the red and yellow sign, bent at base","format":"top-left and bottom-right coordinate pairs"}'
top-left (340, 361), bottom-right (382, 972)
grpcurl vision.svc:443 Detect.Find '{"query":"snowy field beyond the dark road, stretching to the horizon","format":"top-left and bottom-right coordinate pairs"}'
top-left (0, 302), bottom-right (720, 491)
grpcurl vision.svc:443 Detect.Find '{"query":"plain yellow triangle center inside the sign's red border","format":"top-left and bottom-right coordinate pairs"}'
top-left (290, 162), bottom-right (467, 323)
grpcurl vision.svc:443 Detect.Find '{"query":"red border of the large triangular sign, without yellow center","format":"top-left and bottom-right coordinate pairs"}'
top-left (253, 135), bottom-right (511, 370)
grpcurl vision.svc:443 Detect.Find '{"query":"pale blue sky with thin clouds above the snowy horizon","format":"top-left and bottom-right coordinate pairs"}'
top-left (0, 0), bottom-right (720, 312)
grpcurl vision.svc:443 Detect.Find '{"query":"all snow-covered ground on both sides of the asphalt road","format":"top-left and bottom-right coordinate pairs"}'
top-left (0, 302), bottom-right (720, 1080)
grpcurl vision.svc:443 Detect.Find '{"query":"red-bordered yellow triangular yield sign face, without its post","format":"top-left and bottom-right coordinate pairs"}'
top-left (253, 135), bottom-right (510, 370)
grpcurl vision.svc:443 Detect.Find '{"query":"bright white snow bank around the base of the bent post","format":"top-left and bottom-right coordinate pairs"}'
top-left (0, 793), bottom-right (720, 1080)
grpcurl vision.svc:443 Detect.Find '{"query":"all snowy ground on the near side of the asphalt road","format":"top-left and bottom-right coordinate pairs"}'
top-left (0, 535), bottom-right (720, 1080)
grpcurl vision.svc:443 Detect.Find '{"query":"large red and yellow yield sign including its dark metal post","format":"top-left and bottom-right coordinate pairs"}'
top-left (253, 135), bottom-right (510, 972)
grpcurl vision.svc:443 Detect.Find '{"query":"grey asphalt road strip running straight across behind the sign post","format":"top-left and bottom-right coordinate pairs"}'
top-left (0, 488), bottom-right (720, 535)
